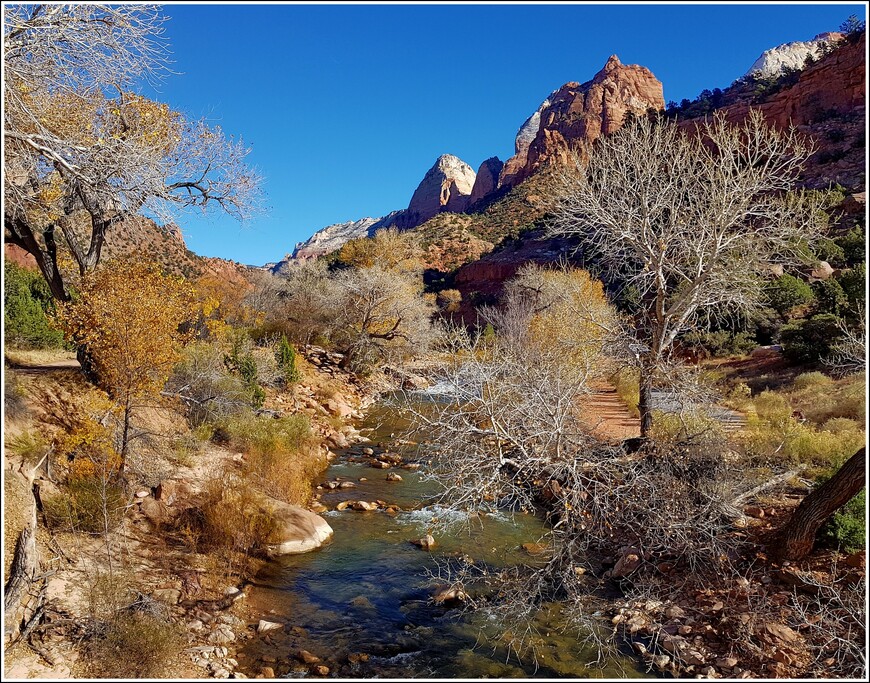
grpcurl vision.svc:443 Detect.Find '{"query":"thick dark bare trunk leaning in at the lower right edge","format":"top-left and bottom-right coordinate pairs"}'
top-left (774, 448), bottom-right (866, 560)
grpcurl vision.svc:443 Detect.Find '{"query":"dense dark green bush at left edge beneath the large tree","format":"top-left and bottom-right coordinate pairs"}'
top-left (3, 261), bottom-right (64, 349)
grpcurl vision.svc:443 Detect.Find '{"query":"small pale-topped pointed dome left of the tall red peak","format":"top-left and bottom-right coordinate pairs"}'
top-left (396, 154), bottom-right (476, 230)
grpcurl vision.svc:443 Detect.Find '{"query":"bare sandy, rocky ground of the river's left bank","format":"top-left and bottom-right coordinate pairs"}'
top-left (4, 347), bottom-right (394, 679)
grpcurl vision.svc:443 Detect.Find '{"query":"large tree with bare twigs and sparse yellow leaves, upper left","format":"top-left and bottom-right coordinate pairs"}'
top-left (3, 3), bottom-right (259, 301)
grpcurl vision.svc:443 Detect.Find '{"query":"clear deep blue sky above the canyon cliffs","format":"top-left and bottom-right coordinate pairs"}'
top-left (141, 3), bottom-right (866, 265)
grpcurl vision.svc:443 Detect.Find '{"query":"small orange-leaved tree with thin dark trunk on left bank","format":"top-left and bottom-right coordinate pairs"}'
top-left (58, 261), bottom-right (194, 468)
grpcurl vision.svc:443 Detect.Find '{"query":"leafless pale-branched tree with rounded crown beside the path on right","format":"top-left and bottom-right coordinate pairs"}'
top-left (549, 110), bottom-right (826, 436)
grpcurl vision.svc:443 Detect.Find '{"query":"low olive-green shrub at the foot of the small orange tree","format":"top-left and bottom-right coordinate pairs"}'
top-left (43, 477), bottom-right (126, 534)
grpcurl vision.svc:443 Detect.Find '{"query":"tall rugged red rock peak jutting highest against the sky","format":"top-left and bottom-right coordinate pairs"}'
top-left (500, 55), bottom-right (665, 187)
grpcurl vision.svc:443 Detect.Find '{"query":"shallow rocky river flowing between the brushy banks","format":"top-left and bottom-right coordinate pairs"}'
top-left (240, 396), bottom-right (646, 678)
